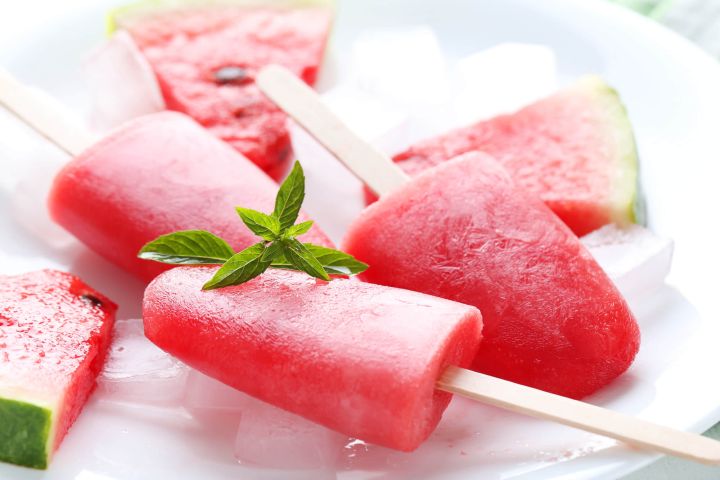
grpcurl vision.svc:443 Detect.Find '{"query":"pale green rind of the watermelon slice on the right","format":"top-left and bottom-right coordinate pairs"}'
top-left (575, 75), bottom-right (645, 229)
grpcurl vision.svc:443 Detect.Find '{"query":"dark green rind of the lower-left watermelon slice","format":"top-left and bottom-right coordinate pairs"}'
top-left (0, 398), bottom-right (53, 470)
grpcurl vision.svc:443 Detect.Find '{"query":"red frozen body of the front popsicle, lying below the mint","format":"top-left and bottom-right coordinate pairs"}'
top-left (143, 267), bottom-right (482, 451)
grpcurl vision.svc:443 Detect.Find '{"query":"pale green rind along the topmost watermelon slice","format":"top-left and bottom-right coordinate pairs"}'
top-left (105, 0), bottom-right (335, 35)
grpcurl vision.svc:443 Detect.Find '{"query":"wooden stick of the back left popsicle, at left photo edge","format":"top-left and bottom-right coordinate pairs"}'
top-left (0, 69), bottom-right (95, 157)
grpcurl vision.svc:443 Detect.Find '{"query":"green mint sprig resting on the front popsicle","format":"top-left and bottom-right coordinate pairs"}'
top-left (138, 162), bottom-right (368, 290)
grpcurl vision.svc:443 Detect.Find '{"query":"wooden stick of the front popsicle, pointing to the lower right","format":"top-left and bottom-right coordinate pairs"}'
top-left (437, 366), bottom-right (720, 465)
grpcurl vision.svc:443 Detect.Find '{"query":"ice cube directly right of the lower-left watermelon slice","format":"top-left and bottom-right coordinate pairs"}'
top-left (98, 319), bottom-right (188, 406)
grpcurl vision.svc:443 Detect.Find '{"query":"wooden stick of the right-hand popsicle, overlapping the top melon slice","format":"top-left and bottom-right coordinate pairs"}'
top-left (255, 65), bottom-right (409, 196)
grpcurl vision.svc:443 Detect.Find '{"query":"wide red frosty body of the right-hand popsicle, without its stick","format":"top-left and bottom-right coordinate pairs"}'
top-left (345, 153), bottom-right (639, 398)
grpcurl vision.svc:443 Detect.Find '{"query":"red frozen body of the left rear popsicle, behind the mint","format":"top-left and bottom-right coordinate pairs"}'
top-left (49, 112), bottom-right (332, 281)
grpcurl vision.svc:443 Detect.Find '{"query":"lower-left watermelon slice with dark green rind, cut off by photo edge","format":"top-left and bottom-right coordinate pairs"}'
top-left (0, 270), bottom-right (116, 469)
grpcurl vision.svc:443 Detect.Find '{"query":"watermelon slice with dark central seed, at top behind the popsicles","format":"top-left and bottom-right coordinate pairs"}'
top-left (111, 1), bottom-right (333, 179)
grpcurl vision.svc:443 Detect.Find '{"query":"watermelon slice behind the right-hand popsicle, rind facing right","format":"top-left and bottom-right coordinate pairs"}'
top-left (369, 76), bottom-right (642, 236)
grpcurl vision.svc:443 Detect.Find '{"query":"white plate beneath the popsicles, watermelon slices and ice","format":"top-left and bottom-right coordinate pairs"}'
top-left (0, 0), bottom-right (720, 480)
